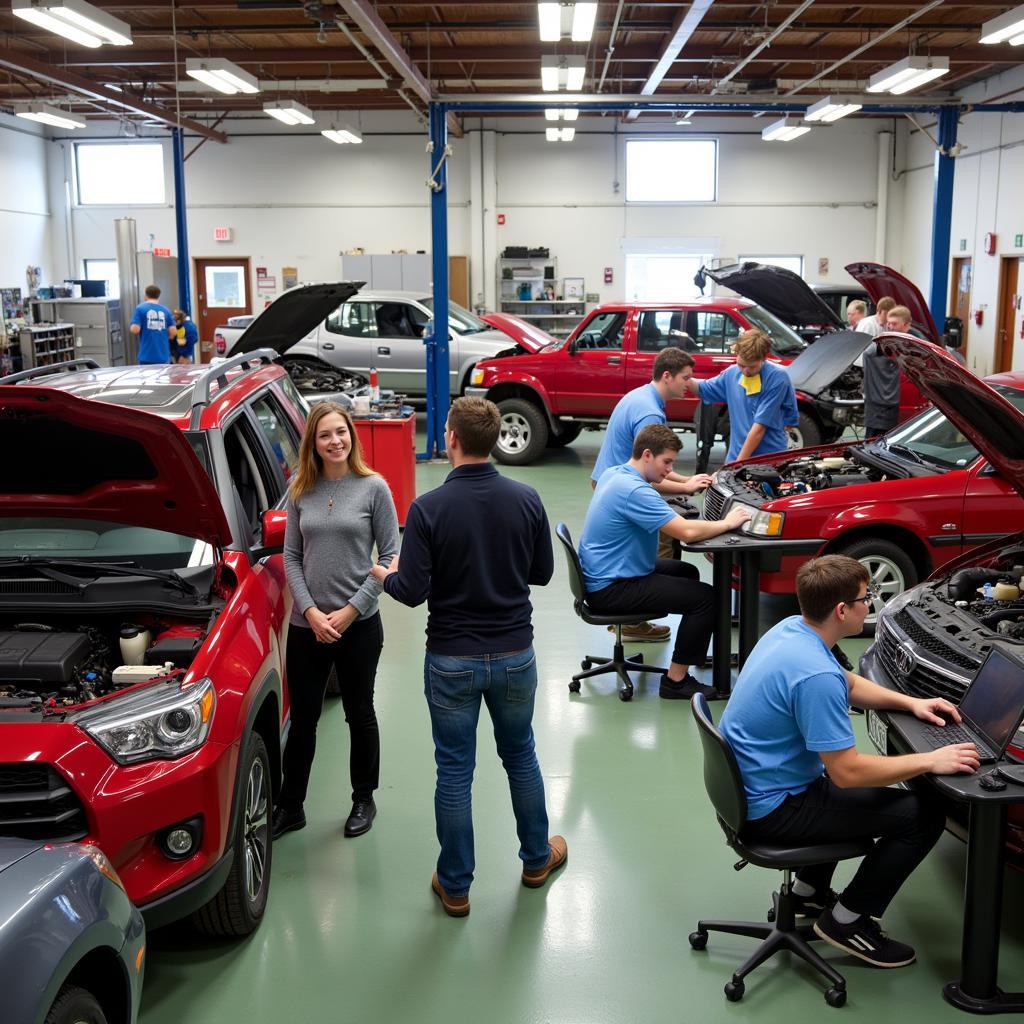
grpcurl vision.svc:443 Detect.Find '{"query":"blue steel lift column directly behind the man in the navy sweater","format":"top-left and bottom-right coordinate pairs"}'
top-left (425, 103), bottom-right (450, 459)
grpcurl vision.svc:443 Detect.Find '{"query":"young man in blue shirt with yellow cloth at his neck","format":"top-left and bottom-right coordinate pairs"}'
top-left (687, 330), bottom-right (800, 462)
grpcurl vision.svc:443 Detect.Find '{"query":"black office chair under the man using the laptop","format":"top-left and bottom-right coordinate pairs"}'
top-left (690, 693), bottom-right (872, 1007)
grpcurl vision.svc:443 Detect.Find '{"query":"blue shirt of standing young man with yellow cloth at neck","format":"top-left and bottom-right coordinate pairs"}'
top-left (700, 360), bottom-right (800, 462)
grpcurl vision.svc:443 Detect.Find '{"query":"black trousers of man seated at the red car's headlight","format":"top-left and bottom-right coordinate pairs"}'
top-left (587, 558), bottom-right (712, 665)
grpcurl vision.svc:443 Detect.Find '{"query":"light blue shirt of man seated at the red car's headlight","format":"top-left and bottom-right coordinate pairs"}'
top-left (580, 465), bottom-right (676, 594)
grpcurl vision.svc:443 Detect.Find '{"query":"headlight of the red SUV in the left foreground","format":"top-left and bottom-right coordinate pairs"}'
top-left (75, 679), bottom-right (217, 765)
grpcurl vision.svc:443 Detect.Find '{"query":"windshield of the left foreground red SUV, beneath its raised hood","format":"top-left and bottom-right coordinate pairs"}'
top-left (0, 517), bottom-right (213, 569)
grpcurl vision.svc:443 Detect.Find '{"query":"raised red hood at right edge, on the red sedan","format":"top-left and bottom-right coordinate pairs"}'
top-left (878, 335), bottom-right (1024, 495)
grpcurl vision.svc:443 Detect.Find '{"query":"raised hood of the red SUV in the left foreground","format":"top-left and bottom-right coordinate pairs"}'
top-left (0, 384), bottom-right (231, 547)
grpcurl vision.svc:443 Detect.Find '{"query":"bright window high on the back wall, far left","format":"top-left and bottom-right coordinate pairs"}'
top-left (75, 142), bottom-right (166, 206)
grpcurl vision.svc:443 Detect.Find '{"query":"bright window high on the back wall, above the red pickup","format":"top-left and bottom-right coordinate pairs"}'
top-left (626, 138), bottom-right (718, 203)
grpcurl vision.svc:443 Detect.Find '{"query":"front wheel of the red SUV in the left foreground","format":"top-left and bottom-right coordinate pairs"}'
top-left (193, 732), bottom-right (273, 938)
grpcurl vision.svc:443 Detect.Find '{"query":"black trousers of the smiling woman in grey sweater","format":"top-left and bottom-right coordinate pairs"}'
top-left (279, 613), bottom-right (384, 810)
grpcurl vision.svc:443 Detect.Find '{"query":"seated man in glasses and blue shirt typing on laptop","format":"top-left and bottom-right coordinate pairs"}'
top-left (719, 555), bottom-right (979, 968)
